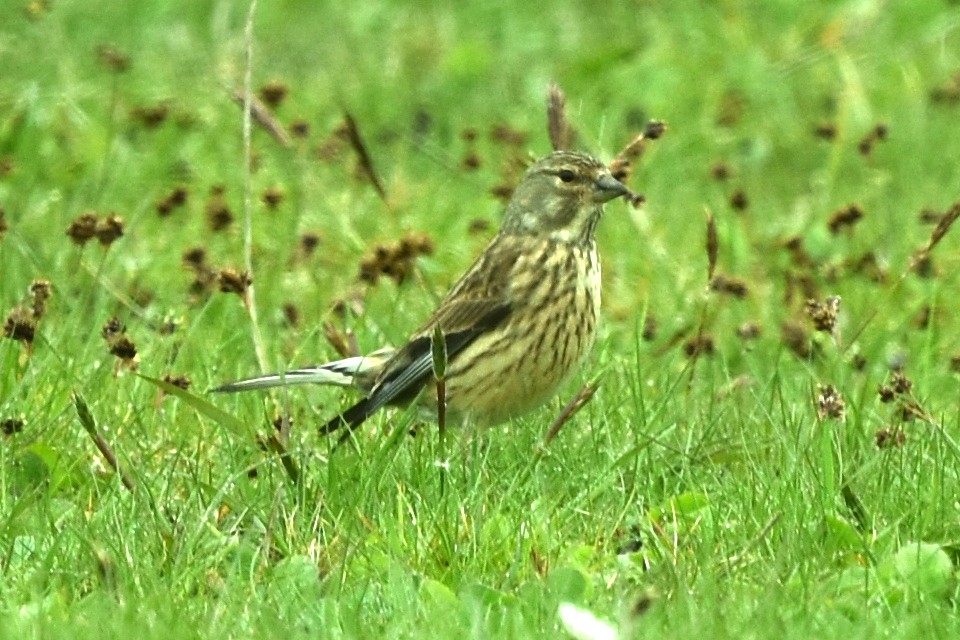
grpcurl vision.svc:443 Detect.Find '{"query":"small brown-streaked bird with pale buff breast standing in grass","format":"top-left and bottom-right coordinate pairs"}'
top-left (212, 150), bottom-right (631, 433)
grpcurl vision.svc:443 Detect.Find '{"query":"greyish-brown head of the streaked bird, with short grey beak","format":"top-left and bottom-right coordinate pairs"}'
top-left (501, 151), bottom-right (629, 244)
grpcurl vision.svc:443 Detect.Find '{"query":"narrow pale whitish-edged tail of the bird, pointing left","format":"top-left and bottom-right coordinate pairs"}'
top-left (210, 348), bottom-right (393, 393)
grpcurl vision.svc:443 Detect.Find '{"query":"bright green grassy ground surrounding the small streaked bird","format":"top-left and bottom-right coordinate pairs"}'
top-left (0, 0), bottom-right (960, 639)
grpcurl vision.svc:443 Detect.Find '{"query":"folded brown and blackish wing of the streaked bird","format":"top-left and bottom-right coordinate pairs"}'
top-left (320, 299), bottom-right (510, 433)
